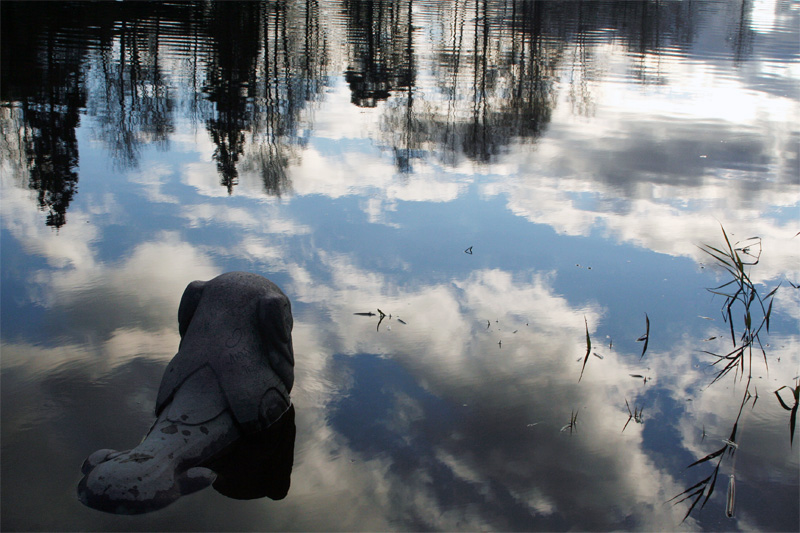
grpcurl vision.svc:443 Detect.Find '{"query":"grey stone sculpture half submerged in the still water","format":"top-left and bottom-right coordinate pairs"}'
top-left (78, 272), bottom-right (294, 514)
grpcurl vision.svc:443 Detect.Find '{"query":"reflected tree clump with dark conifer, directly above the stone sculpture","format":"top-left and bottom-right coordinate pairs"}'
top-left (205, 0), bottom-right (326, 195)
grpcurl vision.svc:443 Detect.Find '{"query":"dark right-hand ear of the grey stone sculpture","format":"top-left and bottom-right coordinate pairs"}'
top-left (258, 291), bottom-right (294, 391)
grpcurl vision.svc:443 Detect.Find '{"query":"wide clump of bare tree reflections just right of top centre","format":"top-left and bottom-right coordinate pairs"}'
top-left (382, 0), bottom-right (564, 171)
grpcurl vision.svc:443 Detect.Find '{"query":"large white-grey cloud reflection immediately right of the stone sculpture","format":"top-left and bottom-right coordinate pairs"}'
top-left (276, 248), bottom-right (700, 529)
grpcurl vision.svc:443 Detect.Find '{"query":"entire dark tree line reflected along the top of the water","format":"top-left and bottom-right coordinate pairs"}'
top-left (0, 0), bottom-right (764, 228)
